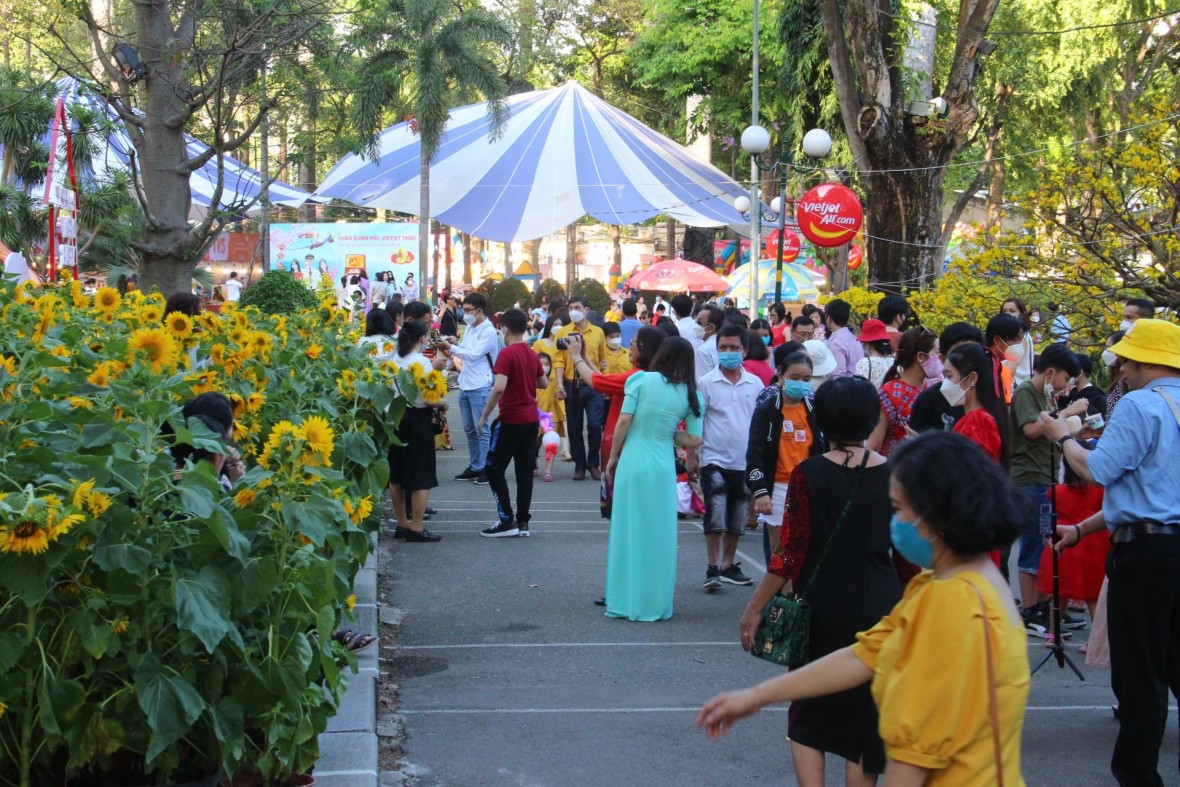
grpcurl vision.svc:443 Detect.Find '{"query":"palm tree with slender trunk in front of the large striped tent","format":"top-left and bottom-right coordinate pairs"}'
top-left (352, 0), bottom-right (511, 304)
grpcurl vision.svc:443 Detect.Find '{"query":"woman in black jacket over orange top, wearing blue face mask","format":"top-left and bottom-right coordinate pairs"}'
top-left (746, 352), bottom-right (827, 563)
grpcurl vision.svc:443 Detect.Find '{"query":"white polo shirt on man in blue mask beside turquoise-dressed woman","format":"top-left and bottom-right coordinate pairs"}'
top-left (696, 367), bottom-right (763, 470)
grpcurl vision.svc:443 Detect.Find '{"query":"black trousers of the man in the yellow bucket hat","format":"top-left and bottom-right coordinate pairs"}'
top-left (1107, 534), bottom-right (1180, 787)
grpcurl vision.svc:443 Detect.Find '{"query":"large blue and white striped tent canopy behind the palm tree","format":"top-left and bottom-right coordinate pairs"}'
top-left (315, 81), bottom-right (746, 241)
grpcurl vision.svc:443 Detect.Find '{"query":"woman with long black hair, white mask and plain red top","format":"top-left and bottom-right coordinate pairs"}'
top-left (940, 343), bottom-right (1008, 468)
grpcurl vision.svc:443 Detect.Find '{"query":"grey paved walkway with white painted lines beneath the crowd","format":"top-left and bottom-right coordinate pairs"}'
top-left (365, 396), bottom-right (1180, 787)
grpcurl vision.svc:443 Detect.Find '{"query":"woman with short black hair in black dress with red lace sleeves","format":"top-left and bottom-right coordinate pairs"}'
top-left (741, 378), bottom-right (902, 787)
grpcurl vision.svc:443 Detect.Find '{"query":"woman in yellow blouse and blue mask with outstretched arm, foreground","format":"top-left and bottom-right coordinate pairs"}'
top-left (696, 432), bottom-right (1029, 787)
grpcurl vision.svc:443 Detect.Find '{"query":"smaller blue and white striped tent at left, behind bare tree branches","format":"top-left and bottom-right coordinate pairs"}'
top-left (13, 78), bottom-right (310, 218)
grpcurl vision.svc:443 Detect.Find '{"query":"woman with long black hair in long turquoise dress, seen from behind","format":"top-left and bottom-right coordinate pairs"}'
top-left (607, 336), bottom-right (703, 621)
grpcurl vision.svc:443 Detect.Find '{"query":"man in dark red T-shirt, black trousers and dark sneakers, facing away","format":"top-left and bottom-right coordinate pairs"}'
top-left (477, 309), bottom-right (549, 538)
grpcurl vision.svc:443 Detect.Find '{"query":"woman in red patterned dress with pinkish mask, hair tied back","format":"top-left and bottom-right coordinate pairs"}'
top-left (868, 328), bottom-right (943, 457)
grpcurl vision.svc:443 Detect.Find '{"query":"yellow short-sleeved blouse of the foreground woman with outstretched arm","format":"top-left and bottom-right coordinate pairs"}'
top-left (852, 571), bottom-right (1029, 787)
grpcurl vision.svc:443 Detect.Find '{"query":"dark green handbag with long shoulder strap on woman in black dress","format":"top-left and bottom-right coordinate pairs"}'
top-left (749, 451), bottom-right (868, 669)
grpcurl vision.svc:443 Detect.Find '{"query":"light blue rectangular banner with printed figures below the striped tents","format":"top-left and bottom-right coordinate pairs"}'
top-left (270, 222), bottom-right (418, 288)
